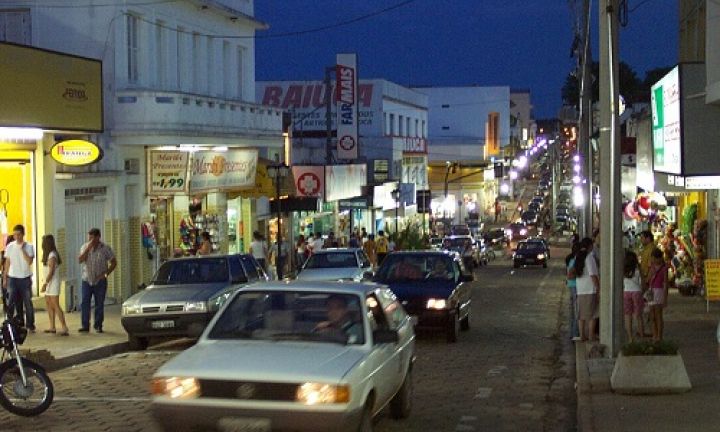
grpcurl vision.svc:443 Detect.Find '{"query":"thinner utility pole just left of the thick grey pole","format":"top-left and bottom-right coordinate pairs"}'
top-left (577, 0), bottom-right (593, 237)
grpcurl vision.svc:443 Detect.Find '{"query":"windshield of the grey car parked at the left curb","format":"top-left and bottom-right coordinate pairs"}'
top-left (152, 258), bottom-right (230, 285)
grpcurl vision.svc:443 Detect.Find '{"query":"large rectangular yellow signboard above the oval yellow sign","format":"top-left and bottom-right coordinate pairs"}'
top-left (0, 43), bottom-right (103, 132)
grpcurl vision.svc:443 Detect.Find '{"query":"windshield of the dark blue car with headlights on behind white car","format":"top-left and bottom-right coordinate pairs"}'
top-left (376, 254), bottom-right (457, 283)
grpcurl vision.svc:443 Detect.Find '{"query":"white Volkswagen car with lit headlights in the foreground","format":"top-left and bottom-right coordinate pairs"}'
top-left (152, 281), bottom-right (415, 432)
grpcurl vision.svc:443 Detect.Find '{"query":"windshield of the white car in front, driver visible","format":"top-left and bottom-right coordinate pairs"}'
top-left (208, 291), bottom-right (365, 345)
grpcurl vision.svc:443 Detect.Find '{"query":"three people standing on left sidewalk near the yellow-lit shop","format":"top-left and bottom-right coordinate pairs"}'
top-left (0, 225), bottom-right (117, 336)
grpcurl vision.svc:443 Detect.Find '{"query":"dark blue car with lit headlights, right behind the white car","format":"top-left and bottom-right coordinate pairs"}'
top-left (373, 251), bottom-right (473, 342)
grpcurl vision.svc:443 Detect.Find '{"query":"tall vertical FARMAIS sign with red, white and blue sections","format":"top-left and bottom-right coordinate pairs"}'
top-left (335, 54), bottom-right (360, 160)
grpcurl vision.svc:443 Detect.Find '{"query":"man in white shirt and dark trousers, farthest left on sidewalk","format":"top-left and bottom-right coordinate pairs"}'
top-left (3, 225), bottom-right (35, 333)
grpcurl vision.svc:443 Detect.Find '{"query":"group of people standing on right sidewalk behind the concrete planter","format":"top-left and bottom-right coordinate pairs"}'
top-left (565, 231), bottom-right (668, 341)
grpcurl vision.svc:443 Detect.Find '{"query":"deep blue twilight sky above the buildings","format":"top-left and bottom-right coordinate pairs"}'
top-left (255, 0), bottom-right (678, 118)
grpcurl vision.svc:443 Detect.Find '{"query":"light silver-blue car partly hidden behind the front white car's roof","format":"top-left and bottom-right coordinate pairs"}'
top-left (297, 248), bottom-right (372, 282)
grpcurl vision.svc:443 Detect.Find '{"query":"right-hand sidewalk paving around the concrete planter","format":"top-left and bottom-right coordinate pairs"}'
top-left (576, 290), bottom-right (720, 432)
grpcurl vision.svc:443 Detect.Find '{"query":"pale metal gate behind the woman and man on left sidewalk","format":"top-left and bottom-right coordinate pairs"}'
top-left (63, 193), bottom-right (105, 310)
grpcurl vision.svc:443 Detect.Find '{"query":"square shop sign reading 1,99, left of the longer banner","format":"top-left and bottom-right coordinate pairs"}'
top-left (147, 150), bottom-right (190, 195)
